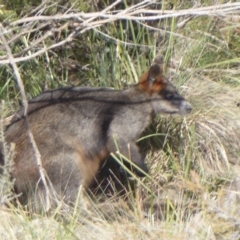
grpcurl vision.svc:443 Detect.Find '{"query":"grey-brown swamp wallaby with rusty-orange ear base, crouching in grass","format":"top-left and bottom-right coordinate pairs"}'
top-left (0, 58), bottom-right (192, 206)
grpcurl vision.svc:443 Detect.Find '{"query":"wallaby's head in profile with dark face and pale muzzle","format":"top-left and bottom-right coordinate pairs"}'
top-left (138, 57), bottom-right (192, 115)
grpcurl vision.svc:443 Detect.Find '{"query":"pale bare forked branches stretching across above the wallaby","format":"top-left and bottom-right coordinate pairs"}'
top-left (0, 0), bottom-right (240, 65)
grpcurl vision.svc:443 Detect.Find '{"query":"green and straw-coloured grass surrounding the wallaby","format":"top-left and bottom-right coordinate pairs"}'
top-left (0, 1), bottom-right (240, 239)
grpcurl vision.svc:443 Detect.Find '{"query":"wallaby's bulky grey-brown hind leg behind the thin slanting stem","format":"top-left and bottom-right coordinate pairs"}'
top-left (14, 147), bottom-right (94, 208)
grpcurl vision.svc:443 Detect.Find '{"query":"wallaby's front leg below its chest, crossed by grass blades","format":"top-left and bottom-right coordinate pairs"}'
top-left (108, 139), bottom-right (148, 177)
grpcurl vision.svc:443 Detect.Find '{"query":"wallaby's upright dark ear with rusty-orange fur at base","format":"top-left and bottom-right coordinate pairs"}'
top-left (139, 56), bottom-right (164, 93)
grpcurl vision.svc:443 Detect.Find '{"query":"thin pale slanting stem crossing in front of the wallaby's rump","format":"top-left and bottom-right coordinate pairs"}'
top-left (0, 23), bottom-right (50, 211)
